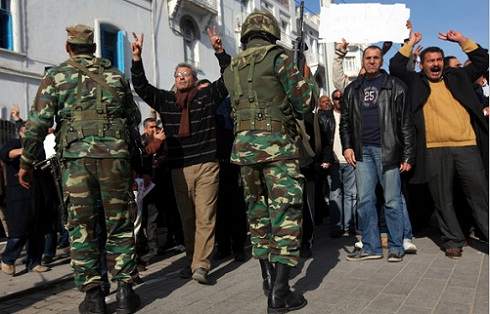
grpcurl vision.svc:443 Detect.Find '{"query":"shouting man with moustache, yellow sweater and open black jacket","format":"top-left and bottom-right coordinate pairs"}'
top-left (390, 27), bottom-right (488, 258)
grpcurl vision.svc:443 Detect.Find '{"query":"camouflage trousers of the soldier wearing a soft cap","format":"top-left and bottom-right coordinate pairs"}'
top-left (63, 158), bottom-right (136, 291)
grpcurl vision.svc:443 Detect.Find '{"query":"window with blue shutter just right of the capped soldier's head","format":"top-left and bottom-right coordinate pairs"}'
top-left (100, 24), bottom-right (126, 73)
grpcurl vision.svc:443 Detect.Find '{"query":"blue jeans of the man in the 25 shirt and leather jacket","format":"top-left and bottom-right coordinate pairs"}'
top-left (356, 146), bottom-right (404, 255)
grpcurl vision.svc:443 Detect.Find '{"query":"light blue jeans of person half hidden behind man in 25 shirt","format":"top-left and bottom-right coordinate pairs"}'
top-left (327, 163), bottom-right (357, 231)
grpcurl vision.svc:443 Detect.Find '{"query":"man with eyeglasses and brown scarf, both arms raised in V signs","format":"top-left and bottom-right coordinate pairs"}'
top-left (131, 29), bottom-right (231, 284)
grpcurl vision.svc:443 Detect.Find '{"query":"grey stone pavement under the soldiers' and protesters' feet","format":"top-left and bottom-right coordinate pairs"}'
top-left (0, 226), bottom-right (489, 314)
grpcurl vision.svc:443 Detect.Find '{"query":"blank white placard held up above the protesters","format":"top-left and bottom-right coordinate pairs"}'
top-left (320, 3), bottom-right (410, 44)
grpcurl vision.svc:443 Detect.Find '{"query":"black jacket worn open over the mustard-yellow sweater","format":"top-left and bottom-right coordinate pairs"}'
top-left (390, 43), bottom-right (488, 183)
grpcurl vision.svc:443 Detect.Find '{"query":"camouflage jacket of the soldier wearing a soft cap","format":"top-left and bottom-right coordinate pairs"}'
top-left (21, 55), bottom-right (141, 168)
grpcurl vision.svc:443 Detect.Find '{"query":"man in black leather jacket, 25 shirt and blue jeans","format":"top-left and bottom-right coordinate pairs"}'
top-left (340, 46), bottom-right (415, 262)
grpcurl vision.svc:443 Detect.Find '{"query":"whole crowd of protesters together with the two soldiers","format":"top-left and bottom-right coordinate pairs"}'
top-left (0, 11), bottom-right (489, 313)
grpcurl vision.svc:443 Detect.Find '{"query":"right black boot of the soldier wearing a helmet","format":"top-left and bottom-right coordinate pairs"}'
top-left (267, 263), bottom-right (307, 314)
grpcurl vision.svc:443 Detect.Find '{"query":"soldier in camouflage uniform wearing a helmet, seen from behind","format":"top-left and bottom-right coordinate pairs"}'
top-left (224, 11), bottom-right (316, 313)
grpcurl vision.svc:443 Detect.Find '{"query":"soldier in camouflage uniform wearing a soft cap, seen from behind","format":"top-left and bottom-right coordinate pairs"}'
top-left (19, 25), bottom-right (141, 313)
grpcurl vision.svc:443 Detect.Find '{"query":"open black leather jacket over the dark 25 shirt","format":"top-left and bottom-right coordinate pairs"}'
top-left (339, 70), bottom-right (415, 169)
